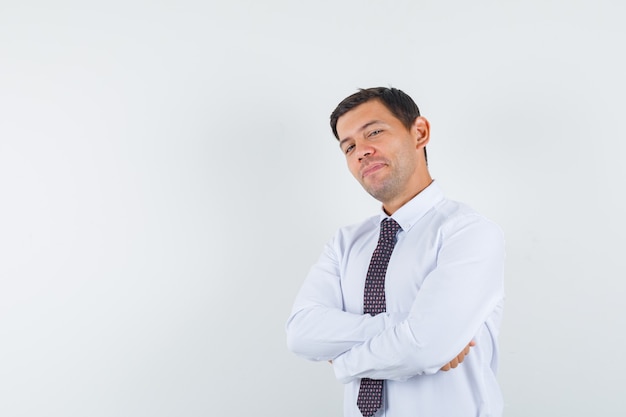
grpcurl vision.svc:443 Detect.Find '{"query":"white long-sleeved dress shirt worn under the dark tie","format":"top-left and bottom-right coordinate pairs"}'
top-left (287, 182), bottom-right (504, 417)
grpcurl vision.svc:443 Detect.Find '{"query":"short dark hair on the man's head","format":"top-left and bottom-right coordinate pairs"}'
top-left (330, 87), bottom-right (428, 162)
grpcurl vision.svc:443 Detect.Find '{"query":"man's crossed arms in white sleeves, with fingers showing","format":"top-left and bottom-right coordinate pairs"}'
top-left (287, 216), bottom-right (504, 382)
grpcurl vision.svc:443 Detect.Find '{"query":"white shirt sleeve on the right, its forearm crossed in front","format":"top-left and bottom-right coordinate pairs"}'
top-left (333, 215), bottom-right (505, 383)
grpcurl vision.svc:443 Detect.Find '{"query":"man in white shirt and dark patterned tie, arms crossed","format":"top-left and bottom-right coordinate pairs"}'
top-left (287, 88), bottom-right (504, 417)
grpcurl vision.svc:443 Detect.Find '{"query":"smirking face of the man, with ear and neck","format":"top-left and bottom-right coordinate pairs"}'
top-left (337, 100), bottom-right (430, 212)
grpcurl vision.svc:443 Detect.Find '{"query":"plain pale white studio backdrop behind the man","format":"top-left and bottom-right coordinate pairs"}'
top-left (0, 0), bottom-right (626, 417)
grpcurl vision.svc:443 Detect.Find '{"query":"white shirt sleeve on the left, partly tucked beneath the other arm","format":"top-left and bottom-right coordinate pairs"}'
top-left (286, 234), bottom-right (407, 360)
